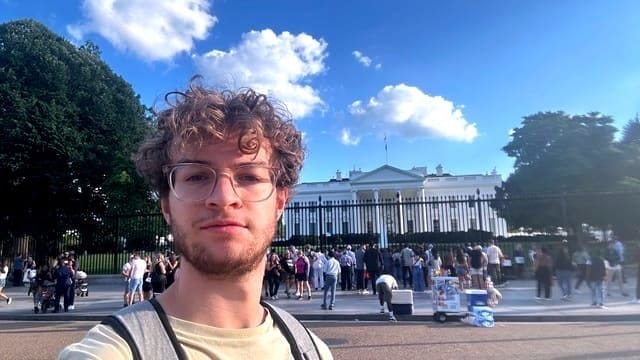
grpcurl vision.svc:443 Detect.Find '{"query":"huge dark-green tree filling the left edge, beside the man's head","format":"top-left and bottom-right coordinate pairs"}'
top-left (0, 20), bottom-right (154, 260)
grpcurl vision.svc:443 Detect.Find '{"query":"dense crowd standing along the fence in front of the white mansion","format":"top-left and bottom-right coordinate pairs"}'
top-left (263, 240), bottom-right (504, 309)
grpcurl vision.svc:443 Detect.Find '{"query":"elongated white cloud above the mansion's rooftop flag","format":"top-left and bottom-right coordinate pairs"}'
top-left (349, 84), bottom-right (478, 142)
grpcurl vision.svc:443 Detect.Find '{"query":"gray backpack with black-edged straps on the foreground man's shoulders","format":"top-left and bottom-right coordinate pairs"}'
top-left (101, 299), bottom-right (320, 360)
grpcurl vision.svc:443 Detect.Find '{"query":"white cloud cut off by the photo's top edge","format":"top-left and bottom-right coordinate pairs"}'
top-left (67, 0), bottom-right (218, 61)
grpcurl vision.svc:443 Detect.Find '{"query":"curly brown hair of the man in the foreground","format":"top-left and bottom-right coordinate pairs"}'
top-left (133, 76), bottom-right (305, 198)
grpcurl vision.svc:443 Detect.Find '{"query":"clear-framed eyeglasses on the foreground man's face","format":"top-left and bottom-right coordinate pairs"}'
top-left (162, 163), bottom-right (276, 202)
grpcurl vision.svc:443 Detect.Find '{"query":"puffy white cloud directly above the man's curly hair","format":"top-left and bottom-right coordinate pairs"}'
top-left (193, 29), bottom-right (328, 118)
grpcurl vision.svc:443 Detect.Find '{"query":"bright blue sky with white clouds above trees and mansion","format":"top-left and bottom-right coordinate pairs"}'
top-left (0, 0), bottom-right (640, 182)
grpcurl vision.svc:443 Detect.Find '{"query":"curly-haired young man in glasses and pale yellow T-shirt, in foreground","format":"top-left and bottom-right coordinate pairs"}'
top-left (59, 81), bottom-right (332, 359)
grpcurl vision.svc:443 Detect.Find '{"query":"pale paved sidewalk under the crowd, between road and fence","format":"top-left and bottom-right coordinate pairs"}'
top-left (0, 275), bottom-right (640, 322)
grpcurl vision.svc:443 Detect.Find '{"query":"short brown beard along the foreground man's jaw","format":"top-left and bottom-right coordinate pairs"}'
top-left (171, 217), bottom-right (275, 279)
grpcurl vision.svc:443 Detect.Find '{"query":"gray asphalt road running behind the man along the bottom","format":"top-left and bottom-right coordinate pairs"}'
top-left (0, 321), bottom-right (640, 360)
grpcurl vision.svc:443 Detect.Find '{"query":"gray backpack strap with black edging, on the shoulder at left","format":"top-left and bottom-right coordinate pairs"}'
top-left (102, 299), bottom-right (186, 360)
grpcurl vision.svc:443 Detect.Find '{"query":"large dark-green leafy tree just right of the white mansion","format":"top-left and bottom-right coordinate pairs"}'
top-left (493, 112), bottom-right (622, 232)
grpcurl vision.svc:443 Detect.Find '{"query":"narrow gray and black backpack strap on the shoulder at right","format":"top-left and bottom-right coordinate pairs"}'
top-left (260, 301), bottom-right (320, 360)
